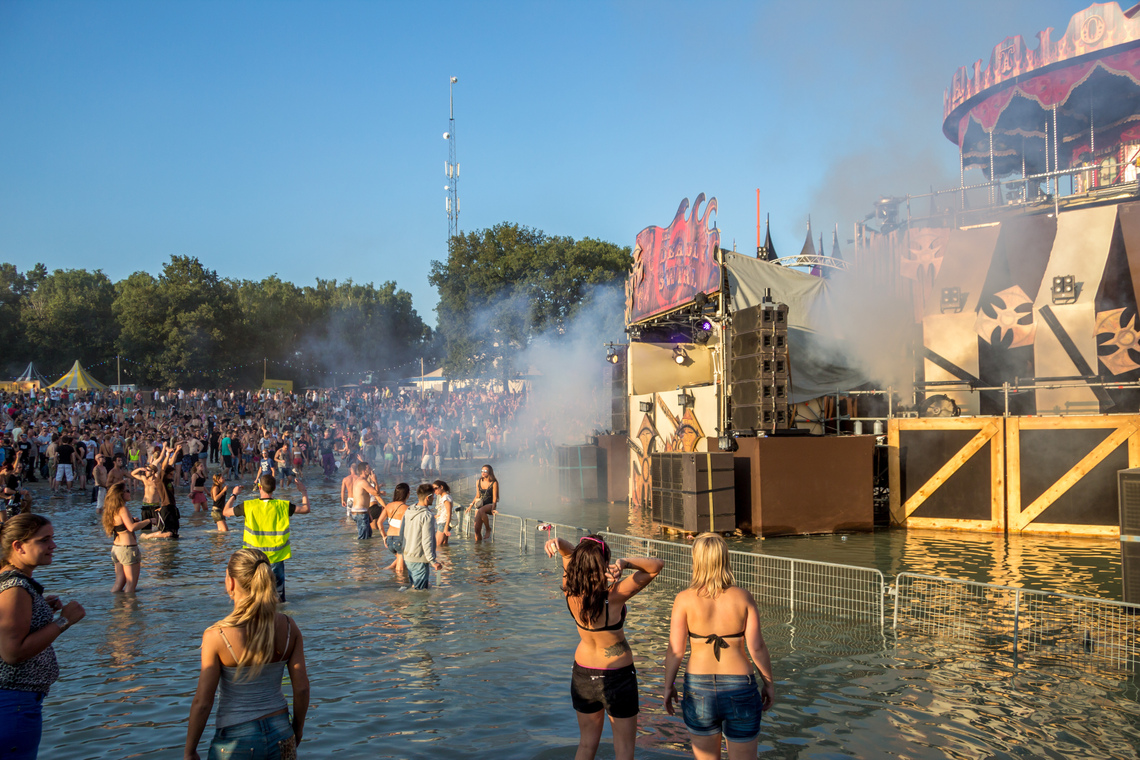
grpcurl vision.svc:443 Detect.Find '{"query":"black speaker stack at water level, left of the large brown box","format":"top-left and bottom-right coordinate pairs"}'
top-left (650, 452), bottom-right (736, 533)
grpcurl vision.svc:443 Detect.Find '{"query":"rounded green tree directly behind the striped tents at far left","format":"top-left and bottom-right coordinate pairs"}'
top-left (19, 269), bottom-right (119, 371)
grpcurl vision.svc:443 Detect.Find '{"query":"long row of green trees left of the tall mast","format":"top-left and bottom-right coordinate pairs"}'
top-left (0, 256), bottom-right (438, 387)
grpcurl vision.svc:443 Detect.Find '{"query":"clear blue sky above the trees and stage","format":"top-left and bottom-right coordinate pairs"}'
top-left (0, 0), bottom-right (1089, 324)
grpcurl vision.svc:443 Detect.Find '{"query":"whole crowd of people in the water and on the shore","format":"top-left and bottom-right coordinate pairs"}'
top-left (0, 392), bottom-right (774, 760)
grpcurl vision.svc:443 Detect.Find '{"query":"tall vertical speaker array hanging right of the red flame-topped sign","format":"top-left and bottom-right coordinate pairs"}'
top-left (728, 300), bottom-right (792, 432)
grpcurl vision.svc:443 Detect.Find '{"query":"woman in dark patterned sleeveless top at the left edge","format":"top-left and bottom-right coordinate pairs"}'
top-left (0, 514), bottom-right (86, 760)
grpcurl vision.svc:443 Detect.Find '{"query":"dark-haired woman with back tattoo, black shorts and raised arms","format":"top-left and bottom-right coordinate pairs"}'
top-left (546, 536), bottom-right (665, 760)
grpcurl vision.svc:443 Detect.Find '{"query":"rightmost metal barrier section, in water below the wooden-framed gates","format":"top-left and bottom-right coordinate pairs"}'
top-left (893, 573), bottom-right (1140, 671)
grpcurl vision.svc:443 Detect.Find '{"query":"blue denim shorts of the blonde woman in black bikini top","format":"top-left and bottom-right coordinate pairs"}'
top-left (681, 673), bottom-right (762, 742)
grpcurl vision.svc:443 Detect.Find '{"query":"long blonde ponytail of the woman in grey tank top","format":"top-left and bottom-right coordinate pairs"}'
top-left (214, 548), bottom-right (277, 678)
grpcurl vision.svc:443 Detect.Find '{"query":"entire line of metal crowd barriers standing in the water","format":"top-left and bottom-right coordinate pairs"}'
top-left (481, 513), bottom-right (1140, 671)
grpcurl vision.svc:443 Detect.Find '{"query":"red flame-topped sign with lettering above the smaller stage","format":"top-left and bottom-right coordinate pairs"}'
top-left (626, 193), bottom-right (720, 325)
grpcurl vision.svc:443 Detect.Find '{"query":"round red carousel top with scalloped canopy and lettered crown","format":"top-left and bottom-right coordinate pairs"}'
top-left (943, 2), bottom-right (1140, 181)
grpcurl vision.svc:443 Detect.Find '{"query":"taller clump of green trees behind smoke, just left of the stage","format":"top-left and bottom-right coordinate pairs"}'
top-left (429, 223), bottom-right (633, 376)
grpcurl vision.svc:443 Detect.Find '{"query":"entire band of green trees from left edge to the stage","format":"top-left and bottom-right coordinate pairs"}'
top-left (0, 222), bottom-right (633, 387)
